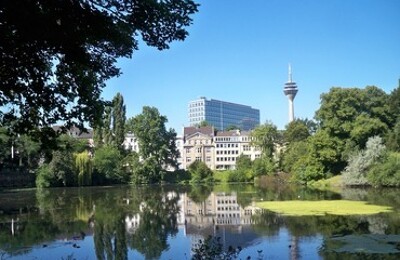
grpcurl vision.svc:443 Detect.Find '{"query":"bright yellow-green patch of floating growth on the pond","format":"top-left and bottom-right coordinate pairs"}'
top-left (256, 200), bottom-right (393, 216)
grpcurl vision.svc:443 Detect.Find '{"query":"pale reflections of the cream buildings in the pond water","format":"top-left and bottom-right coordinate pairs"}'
top-left (125, 192), bottom-right (256, 251)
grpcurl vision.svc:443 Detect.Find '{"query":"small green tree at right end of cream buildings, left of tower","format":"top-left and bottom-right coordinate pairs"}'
top-left (251, 122), bottom-right (278, 157)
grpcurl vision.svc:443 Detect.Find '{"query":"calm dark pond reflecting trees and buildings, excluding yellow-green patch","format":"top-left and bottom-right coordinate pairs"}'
top-left (0, 184), bottom-right (400, 259)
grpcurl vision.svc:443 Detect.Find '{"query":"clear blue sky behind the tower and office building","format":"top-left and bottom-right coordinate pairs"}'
top-left (103, 0), bottom-right (400, 131)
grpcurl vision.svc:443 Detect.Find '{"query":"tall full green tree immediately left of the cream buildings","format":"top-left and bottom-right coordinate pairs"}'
top-left (132, 106), bottom-right (179, 182)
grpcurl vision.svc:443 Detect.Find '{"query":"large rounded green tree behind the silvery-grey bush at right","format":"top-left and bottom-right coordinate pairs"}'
top-left (310, 86), bottom-right (393, 174)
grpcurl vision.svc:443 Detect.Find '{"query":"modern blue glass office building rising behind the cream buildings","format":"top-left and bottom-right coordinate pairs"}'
top-left (188, 97), bottom-right (260, 131)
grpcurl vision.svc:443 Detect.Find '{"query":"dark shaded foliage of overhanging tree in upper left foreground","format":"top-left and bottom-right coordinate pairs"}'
top-left (0, 0), bottom-right (198, 132)
